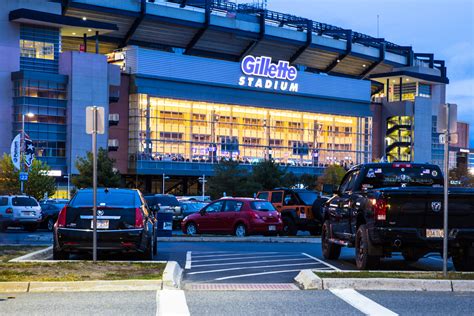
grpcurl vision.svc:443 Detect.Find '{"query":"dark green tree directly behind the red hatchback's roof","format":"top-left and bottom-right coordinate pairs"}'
top-left (207, 160), bottom-right (251, 199)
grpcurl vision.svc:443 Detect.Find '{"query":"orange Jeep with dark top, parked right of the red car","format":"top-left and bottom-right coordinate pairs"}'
top-left (257, 188), bottom-right (321, 236)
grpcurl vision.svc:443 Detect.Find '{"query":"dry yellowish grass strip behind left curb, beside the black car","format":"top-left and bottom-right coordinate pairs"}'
top-left (0, 247), bottom-right (165, 282)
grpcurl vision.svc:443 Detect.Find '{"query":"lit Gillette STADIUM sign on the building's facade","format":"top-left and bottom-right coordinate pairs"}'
top-left (239, 55), bottom-right (299, 92)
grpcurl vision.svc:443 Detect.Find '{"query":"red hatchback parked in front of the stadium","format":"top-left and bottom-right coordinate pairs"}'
top-left (181, 198), bottom-right (283, 237)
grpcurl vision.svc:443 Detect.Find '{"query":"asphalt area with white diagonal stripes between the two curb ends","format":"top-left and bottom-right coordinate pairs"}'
top-left (184, 251), bottom-right (338, 288)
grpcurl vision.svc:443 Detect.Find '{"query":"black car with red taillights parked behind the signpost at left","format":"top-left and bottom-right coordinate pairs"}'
top-left (53, 188), bottom-right (157, 260)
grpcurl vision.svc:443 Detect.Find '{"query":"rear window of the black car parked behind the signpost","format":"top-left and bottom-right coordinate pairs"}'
top-left (69, 191), bottom-right (138, 207)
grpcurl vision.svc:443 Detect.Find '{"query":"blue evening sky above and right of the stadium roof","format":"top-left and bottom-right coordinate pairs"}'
top-left (260, 0), bottom-right (474, 147)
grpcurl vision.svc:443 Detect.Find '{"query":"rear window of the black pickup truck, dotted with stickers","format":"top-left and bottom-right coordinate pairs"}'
top-left (362, 164), bottom-right (443, 189)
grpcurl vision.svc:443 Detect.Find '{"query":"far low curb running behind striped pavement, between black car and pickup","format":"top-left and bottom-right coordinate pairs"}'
top-left (157, 236), bottom-right (321, 244)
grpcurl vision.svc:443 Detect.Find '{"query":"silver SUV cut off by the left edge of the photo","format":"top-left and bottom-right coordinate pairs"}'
top-left (0, 195), bottom-right (41, 232)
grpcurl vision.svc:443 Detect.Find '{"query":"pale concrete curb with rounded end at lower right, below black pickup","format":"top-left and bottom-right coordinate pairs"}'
top-left (294, 270), bottom-right (474, 292)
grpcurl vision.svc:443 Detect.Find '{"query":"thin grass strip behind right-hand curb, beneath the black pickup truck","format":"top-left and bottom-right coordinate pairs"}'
top-left (314, 271), bottom-right (474, 280)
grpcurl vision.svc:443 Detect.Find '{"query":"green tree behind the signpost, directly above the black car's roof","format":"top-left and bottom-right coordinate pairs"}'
top-left (72, 148), bottom-right (121, 189)
